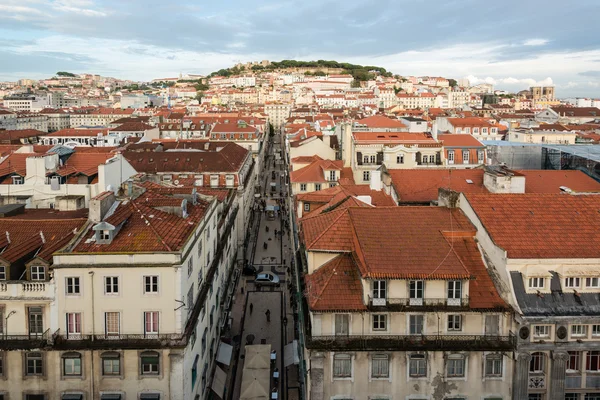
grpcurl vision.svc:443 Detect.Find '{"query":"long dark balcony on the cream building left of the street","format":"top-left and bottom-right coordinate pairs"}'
top-left (52, 330), bottom-right (186, 350)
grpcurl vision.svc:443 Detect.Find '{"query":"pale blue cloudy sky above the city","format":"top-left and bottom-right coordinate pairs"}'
top-left (0, 0), bottom-right (600, 98)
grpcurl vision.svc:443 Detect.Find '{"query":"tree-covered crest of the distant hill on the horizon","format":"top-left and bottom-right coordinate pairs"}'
top-left (209, 60), bottom-right (392, 82)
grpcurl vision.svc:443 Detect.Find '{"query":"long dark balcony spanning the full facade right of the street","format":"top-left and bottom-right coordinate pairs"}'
top-left (306, 332), bottom-right (516, 351)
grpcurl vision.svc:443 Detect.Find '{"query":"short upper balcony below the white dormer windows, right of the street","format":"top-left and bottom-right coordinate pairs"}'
top-left (367, 296), bottom-right (469, 311)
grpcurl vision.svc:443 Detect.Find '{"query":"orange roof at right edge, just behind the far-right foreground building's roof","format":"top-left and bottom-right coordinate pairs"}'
top-left (516, 170), bottom-right (600, 193)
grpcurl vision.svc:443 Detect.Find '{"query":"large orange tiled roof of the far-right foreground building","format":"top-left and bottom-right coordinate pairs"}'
top-left (466, 194), bottom-right (600, 259)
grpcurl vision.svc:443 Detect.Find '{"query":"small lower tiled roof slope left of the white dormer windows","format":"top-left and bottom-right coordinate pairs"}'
top-left (305, 255), bottom-right (366, 311)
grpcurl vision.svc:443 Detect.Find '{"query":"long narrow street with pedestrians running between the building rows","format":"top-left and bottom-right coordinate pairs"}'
top-left (226, 135), bottom-right (299, 400)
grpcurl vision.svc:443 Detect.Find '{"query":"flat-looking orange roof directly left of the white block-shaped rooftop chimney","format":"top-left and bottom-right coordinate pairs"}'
top-left (387, 168), bottom-right (488, 203)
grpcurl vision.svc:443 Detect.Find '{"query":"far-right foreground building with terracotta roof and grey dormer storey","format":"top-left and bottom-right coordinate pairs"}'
top-left (459, 193), bottom-right (600, 400)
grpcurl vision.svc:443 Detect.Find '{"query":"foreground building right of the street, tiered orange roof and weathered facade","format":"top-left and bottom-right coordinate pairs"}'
top-left (300, 207), bottom-right (516, 400)
